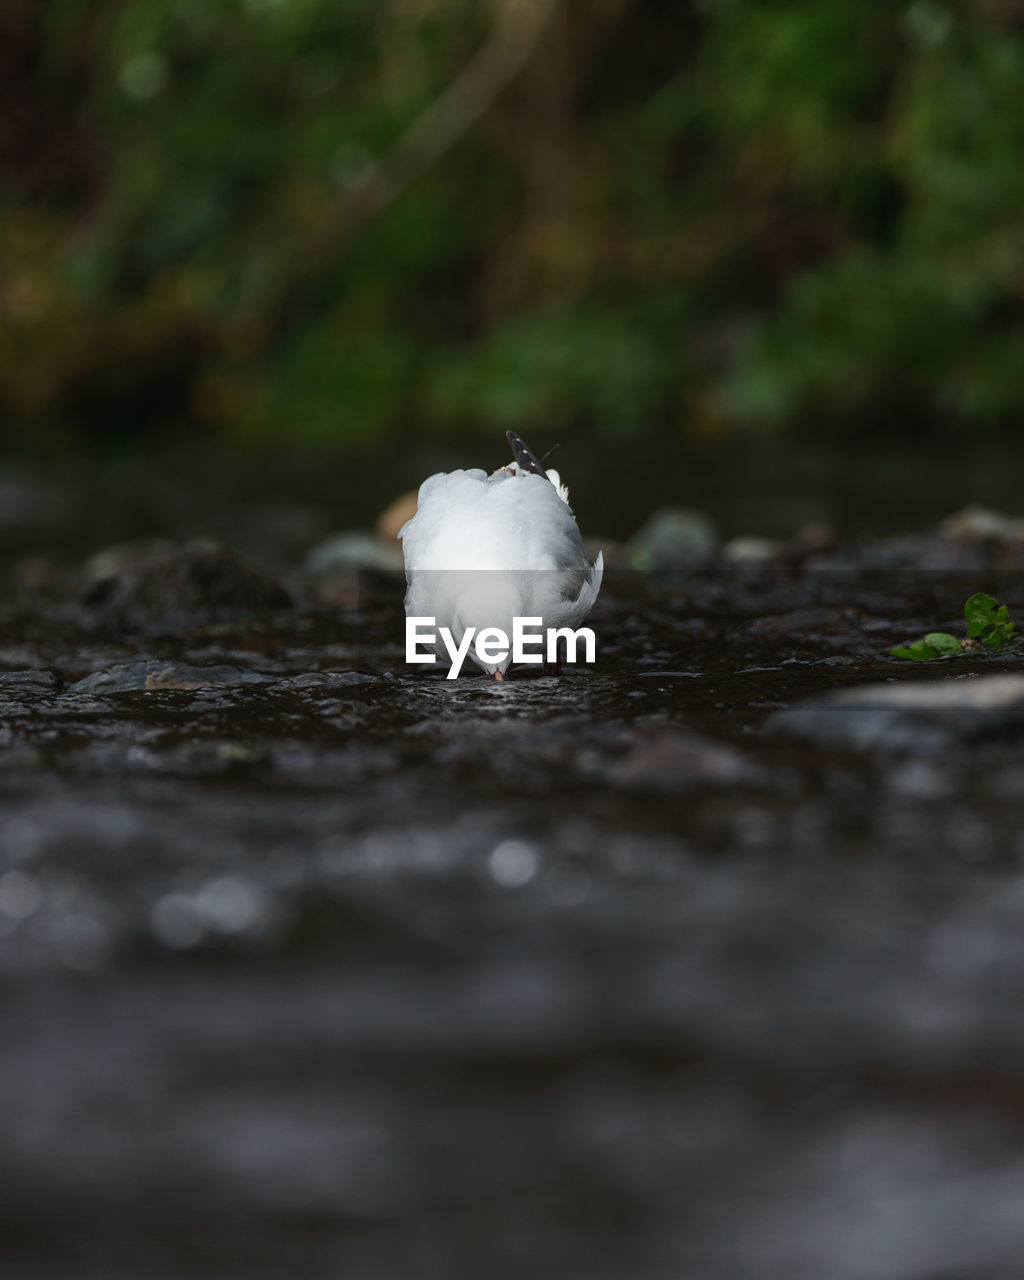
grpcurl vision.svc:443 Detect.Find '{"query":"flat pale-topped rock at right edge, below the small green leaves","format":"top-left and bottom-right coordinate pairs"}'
top-left (765, 675), bottom-right (1024, 753)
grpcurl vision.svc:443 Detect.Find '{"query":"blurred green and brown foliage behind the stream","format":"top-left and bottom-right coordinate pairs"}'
top-left (0, 0), bottom-right (1024, 451)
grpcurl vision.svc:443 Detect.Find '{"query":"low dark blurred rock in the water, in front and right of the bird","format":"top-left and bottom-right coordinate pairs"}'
top-left (609, 731), bottom-right (764, 791)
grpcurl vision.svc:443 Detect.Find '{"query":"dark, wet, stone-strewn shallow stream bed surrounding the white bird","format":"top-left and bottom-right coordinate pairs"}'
top-left (0, 455), bottom-right (1024, 1280)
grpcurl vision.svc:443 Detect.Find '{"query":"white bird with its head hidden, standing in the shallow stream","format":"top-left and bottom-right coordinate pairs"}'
top-left (398, 431), bottom-right (604, 680)
